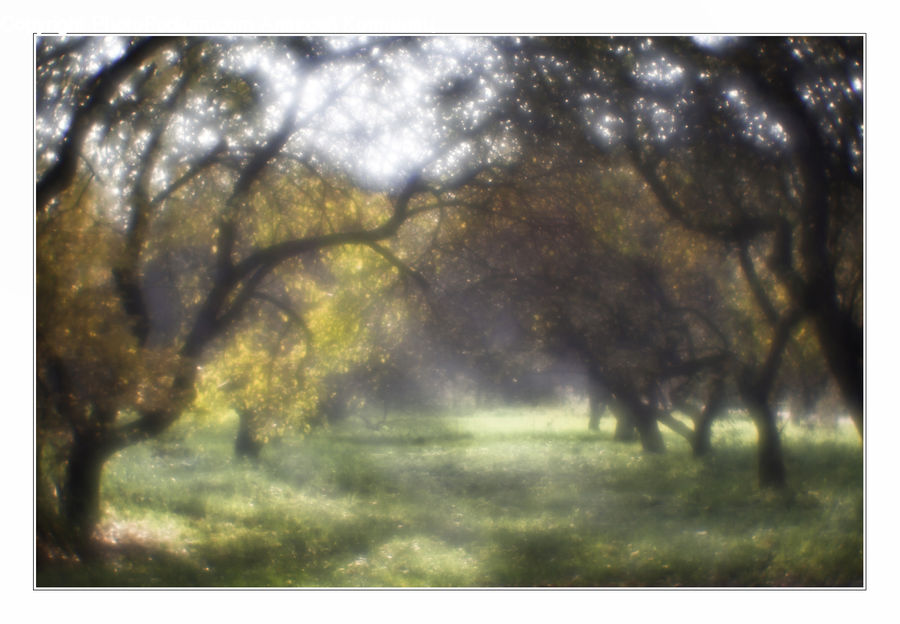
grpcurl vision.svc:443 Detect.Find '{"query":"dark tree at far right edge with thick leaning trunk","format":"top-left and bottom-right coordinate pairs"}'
top-left (616, 38), bottom-right (863, 433)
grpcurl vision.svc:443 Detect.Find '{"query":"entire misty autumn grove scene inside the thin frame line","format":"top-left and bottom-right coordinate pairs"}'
top-left (34, 35), bottom-right (866, 588)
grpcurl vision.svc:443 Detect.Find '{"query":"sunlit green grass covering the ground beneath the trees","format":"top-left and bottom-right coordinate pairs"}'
top-left (37, 407), bottom-right (863, 587)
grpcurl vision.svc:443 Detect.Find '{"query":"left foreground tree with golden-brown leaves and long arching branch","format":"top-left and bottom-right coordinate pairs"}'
top-left (36, 38), bottom-right (482, 550)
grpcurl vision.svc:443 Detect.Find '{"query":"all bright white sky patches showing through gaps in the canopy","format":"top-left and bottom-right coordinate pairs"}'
top-left (36, 36), bottom-right (862, 206)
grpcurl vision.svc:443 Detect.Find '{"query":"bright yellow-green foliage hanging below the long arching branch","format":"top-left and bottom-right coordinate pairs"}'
top-left (195, 238), bottom-right (414, 443)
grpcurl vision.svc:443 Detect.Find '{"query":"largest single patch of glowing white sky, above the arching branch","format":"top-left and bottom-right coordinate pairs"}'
top-left (227, 37), bottom-right (512, 188)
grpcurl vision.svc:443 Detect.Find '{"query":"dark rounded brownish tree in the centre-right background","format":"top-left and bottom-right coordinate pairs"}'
top-left (423, 150), bottom-right (727, 451)
